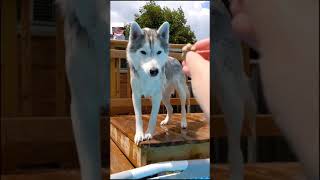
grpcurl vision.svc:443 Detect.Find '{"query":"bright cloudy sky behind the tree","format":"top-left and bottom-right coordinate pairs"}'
top-left (110, 1), bottom-right (210, 40)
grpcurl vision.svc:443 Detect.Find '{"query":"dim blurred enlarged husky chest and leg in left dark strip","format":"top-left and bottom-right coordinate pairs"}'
top-left (57, 0), bottom-right (109, 180)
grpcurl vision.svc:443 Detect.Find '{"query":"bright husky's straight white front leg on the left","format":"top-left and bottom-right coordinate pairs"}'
top-left (132, 93), bottom-right (143, 144)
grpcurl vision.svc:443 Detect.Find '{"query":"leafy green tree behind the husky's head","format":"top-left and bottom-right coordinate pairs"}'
top-left (125, 1), bottom-right (196, 44)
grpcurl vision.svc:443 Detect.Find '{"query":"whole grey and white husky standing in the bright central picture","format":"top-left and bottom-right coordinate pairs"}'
top-left (127, 22), bottom-right (189, 144)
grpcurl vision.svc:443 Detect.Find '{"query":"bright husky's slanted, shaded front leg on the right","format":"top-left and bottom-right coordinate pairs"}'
top-left (144, 93), bottom-right (162, 140)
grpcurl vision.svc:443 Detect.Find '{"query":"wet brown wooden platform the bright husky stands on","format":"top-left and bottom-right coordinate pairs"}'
top-left (111, 114), bottom-right (210, 167)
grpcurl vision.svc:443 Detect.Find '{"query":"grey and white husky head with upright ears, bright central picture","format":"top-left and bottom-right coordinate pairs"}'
top-left (127, 22), bottom-right (169, 78)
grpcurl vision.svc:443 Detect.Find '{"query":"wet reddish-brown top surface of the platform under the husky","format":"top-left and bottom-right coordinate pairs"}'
top-left (111, 113), bottom-right (209, 147)
